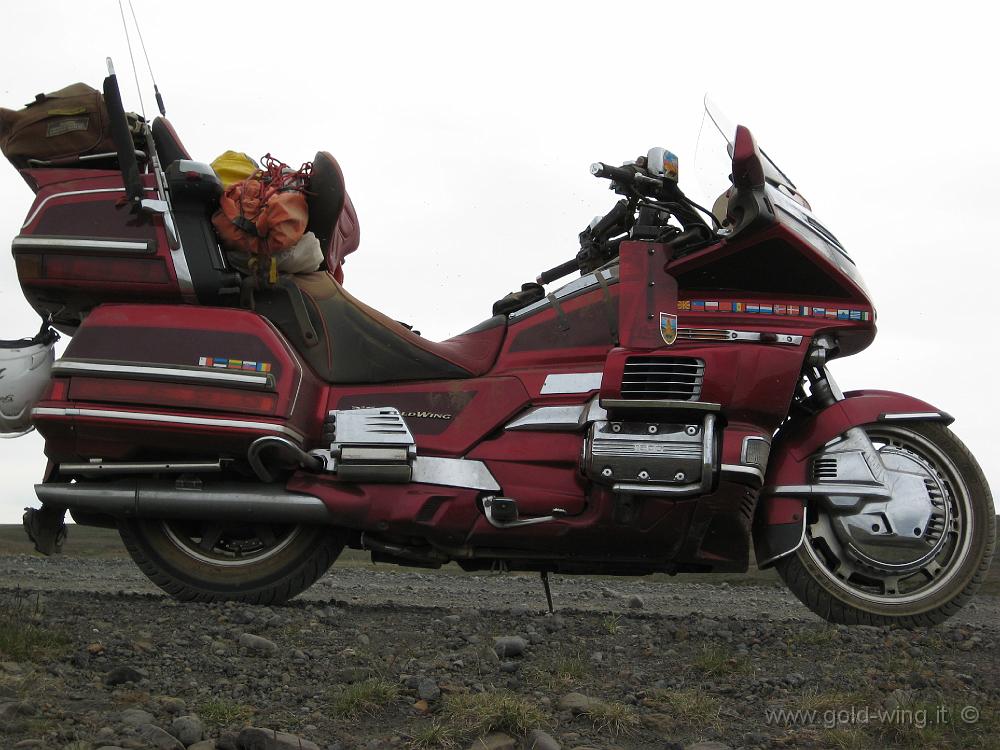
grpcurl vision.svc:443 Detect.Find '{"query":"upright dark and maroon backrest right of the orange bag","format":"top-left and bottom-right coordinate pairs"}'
top-left (306, 151), bottom-right (361, 283)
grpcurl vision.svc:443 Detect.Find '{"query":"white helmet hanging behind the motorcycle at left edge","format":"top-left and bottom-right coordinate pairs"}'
top-left (0, 321), bottom-right (59, 437)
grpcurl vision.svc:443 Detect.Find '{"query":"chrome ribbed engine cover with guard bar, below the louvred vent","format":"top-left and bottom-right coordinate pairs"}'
top-left (583, 414), bottom-right (717, 496)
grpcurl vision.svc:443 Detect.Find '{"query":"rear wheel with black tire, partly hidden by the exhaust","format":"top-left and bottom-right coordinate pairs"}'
top-left (118, 520), bottom-right (344, 604)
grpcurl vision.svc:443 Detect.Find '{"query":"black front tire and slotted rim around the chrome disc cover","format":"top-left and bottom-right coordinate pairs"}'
top-left (775, 422), bottom-right (996, 627)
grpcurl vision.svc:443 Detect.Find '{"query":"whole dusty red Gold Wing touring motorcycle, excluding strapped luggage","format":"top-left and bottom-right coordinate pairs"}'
top-left (0, 70), bottom-right (995, 626)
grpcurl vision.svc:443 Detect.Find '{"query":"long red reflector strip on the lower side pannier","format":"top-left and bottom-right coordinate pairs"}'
top-left (68, 377), bottom-right (277, 414)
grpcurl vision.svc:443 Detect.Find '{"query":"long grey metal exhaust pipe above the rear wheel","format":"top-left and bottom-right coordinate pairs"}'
top-left (35, 479), bottom-right (331, 524)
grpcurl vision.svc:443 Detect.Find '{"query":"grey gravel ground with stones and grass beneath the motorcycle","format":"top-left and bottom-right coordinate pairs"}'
top-left (0, 554), bottom-right (1000, 750)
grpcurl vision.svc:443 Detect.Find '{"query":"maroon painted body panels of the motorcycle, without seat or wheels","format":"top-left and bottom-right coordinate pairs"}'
top-left (9, 123), bottom-right (936, 572)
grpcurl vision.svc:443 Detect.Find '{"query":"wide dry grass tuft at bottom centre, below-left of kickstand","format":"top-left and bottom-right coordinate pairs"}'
top-left (441, 690), bottom-right (546, 737)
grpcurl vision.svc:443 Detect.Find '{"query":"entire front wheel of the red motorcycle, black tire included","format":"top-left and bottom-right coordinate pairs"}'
top-left (775, 422), bottom-right (996, 627)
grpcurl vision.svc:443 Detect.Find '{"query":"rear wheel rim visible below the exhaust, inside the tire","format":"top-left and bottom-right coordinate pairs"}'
top-left (160, 521), bottom-right (302, 568)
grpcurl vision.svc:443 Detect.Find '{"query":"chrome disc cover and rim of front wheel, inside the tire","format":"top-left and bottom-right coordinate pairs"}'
top-left (802, 425), bottom-right (973, 606)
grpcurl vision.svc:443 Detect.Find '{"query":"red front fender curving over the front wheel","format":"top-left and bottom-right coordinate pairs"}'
top-left (753, 391), bottom-right (954, 568)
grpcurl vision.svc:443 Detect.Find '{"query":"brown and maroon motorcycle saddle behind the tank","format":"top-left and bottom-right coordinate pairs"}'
top-left (255, 271), bottom-right (507, 384)
